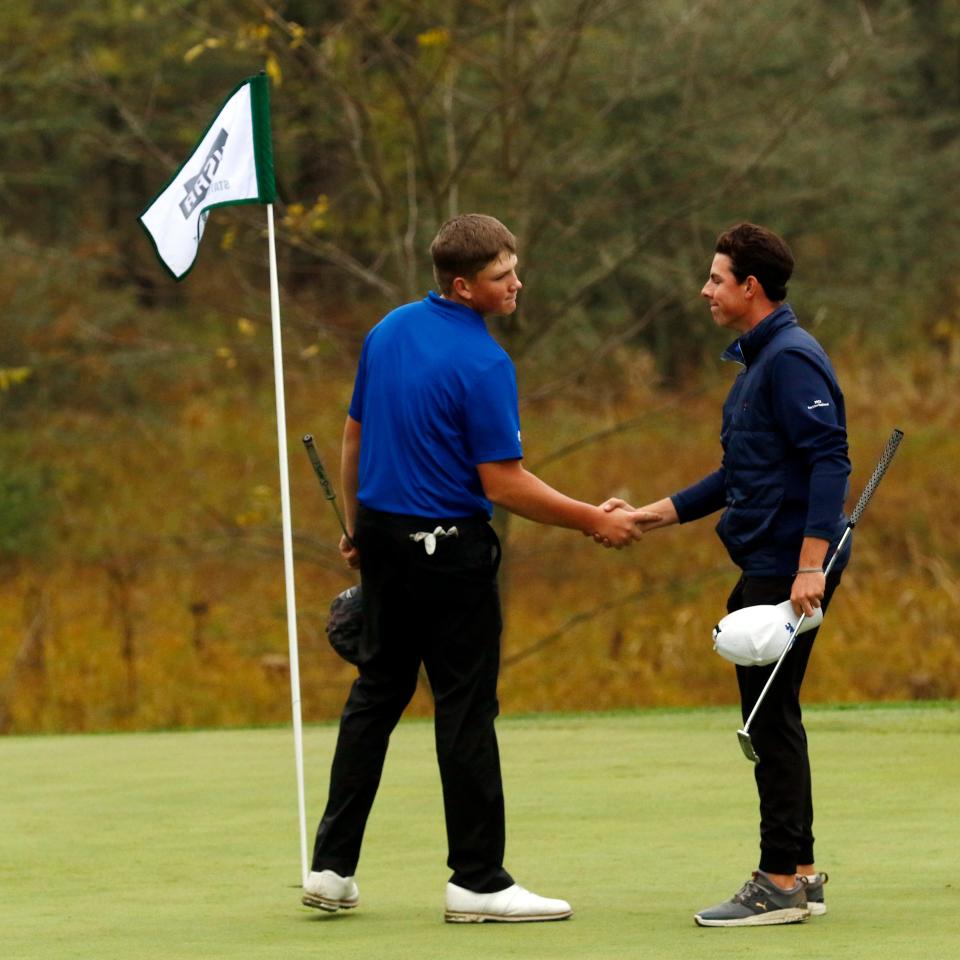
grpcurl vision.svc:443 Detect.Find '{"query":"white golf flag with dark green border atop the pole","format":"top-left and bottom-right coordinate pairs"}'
top-left (139, 74), bottom-right (277, 280)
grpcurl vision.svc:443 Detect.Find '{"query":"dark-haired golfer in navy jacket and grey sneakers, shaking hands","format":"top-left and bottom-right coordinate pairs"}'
top-left (606, 223), bottom-right (850, 926)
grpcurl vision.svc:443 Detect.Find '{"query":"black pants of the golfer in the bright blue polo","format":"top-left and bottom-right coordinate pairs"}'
top-left (313, 508), bottom-right (513, 893)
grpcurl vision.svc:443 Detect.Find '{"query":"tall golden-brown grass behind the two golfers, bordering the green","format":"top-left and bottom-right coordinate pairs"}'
top-left (0, 346), bottom-right (960, 731)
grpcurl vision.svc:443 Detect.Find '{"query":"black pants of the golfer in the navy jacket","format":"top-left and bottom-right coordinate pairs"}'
top-left (727, 571), bottom-right (841, 874)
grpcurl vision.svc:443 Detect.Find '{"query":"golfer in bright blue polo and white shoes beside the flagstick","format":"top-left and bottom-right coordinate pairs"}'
top-left (303, 214), bottom-right (655, 922)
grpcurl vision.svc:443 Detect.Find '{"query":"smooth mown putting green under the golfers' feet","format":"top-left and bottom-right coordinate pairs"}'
top-left (0, 703), bottom-right (960, 960)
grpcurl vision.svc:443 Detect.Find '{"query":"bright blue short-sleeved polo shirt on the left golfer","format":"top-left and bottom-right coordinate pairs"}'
top-left (350, 292), bottom-right (523, 518)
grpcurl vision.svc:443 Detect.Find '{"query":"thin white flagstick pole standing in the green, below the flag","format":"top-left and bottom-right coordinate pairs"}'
top-left (267, 203), bottom-right (307, 883)
